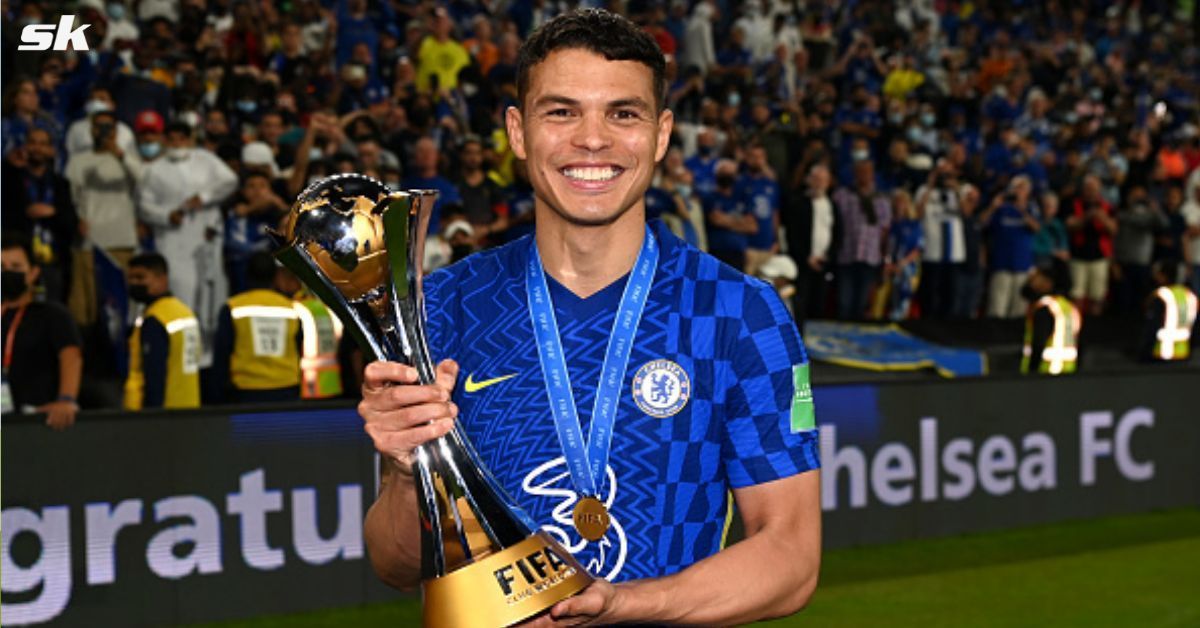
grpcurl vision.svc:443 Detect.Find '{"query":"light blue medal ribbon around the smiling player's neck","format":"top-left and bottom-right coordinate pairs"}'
top-left (526, 227), bottom-right (659, 496)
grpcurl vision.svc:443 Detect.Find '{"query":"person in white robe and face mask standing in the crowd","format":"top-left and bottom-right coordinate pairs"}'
top-left (138, 122), bottom-right (238, 348)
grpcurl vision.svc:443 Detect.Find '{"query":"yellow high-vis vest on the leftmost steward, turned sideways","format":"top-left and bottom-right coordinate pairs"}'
top-left (125, 297), bottom-right (202, 409)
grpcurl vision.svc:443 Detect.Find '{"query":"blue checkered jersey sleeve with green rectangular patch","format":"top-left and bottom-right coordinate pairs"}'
top-left (722, 280), bottom-right (821, 489)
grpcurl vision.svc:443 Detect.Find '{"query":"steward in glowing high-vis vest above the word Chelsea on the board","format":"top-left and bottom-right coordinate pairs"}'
top-left (1021, 258), bottom-right (1082, 375)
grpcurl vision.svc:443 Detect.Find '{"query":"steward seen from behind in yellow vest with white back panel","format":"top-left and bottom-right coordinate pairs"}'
top-left (211, 252), bottom-right (302, 403)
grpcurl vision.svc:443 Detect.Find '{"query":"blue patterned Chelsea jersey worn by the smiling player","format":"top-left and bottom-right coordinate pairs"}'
top-left (425, 222), bottom-right (820, 581)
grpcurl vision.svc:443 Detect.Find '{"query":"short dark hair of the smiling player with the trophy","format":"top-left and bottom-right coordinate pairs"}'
top-left (517, 8), bottom-right (667, 109)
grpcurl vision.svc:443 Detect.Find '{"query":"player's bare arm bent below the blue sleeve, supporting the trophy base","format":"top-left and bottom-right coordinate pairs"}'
top-left (545, 471), bottom-right (821, 626)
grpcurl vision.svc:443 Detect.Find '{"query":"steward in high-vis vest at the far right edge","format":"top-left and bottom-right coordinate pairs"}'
top-left (1142, 262), bottom-right (1198, 361)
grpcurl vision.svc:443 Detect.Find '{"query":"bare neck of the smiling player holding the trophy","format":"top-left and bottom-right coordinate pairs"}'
top-left (534, 202), bottom-right (646, 298)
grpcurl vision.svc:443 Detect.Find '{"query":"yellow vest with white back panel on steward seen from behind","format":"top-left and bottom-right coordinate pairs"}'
top-left (226, 289), bottom-right (300, 390)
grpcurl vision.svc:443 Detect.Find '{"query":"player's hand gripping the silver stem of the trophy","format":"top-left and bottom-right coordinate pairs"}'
top-left (359, 360), bottom-right (458, 474)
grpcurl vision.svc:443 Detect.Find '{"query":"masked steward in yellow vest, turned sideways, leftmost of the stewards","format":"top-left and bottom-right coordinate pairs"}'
top-left (125, 253), bottom-right (200, 409)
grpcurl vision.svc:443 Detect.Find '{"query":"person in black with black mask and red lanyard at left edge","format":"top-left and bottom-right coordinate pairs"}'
top-left (0, 233), bottom-right (83, 430)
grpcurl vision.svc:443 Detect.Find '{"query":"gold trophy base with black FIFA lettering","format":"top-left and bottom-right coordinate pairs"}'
top-left (421, 531), bottom-right (593, 628)
